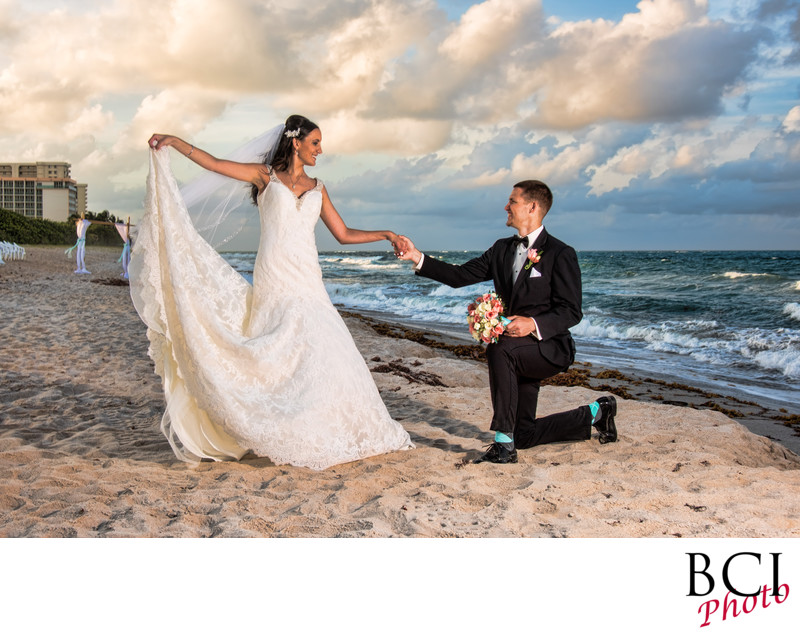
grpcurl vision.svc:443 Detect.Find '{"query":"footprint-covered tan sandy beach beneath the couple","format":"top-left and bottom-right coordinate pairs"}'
top-left (0, 246), bottom-right (800, 538)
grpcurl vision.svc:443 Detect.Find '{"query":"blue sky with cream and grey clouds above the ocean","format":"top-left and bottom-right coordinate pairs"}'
top-left (0, 0), bottom-right (800, 249)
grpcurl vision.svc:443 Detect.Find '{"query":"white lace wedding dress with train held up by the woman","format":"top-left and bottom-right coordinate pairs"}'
top-left (129, 148), bottom-right (413, 470)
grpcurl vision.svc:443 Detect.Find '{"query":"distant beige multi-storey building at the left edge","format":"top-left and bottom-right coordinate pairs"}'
top-left (0, 161), bottom-right (87, 221)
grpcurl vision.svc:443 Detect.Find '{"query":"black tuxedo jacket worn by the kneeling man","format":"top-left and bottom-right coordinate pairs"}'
top-left (417, 229), bottom-right (583, 369)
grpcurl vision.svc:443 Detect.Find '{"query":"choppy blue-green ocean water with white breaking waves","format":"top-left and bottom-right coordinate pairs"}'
top-left (223, 251), bottom-right (800, 413)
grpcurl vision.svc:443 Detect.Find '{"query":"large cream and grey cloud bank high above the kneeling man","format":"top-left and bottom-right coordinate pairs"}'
top-left (360, 0), bottom-right (757, 134)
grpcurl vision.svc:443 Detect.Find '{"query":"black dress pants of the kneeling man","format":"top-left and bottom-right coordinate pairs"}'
top-left (486, 336), bottom-right (592, 448)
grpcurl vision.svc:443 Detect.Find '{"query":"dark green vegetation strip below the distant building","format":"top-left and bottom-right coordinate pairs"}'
top-left (0, 209), bottom-right (122, 247)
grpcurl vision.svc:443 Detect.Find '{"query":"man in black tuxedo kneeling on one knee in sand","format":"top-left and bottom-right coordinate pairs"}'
top-left (398, 180), bottom-right (617, 464)
